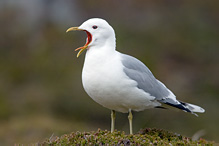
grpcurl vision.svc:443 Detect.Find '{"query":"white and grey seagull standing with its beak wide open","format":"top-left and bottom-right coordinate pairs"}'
top-left (66, 18), bottom-right (205, 134)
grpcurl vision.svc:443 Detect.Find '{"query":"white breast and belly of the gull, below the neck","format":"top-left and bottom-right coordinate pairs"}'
top-left (82, 50), bottom-right (158, 112)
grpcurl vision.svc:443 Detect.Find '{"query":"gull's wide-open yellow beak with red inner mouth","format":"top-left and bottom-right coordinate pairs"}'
top-left (66, 27), bottom-right (92, 57)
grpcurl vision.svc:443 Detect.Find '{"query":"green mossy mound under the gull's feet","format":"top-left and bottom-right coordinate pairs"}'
top-left (42, 128), bottom-right (213, 146)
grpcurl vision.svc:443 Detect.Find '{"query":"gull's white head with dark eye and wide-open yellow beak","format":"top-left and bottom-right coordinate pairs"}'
top-left (66, 18), bottom-right (115, 57)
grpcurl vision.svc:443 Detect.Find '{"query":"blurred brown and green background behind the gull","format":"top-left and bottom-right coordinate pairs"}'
top-left (0, 0), bottom-right (219, 145)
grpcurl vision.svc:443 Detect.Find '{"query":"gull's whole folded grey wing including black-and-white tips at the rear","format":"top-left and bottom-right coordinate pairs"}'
top-left (122, 54), bottom-right (204, 115)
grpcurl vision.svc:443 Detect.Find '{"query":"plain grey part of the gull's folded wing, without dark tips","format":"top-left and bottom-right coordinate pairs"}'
top-left (122, 54), bottom-right (170, 100)
